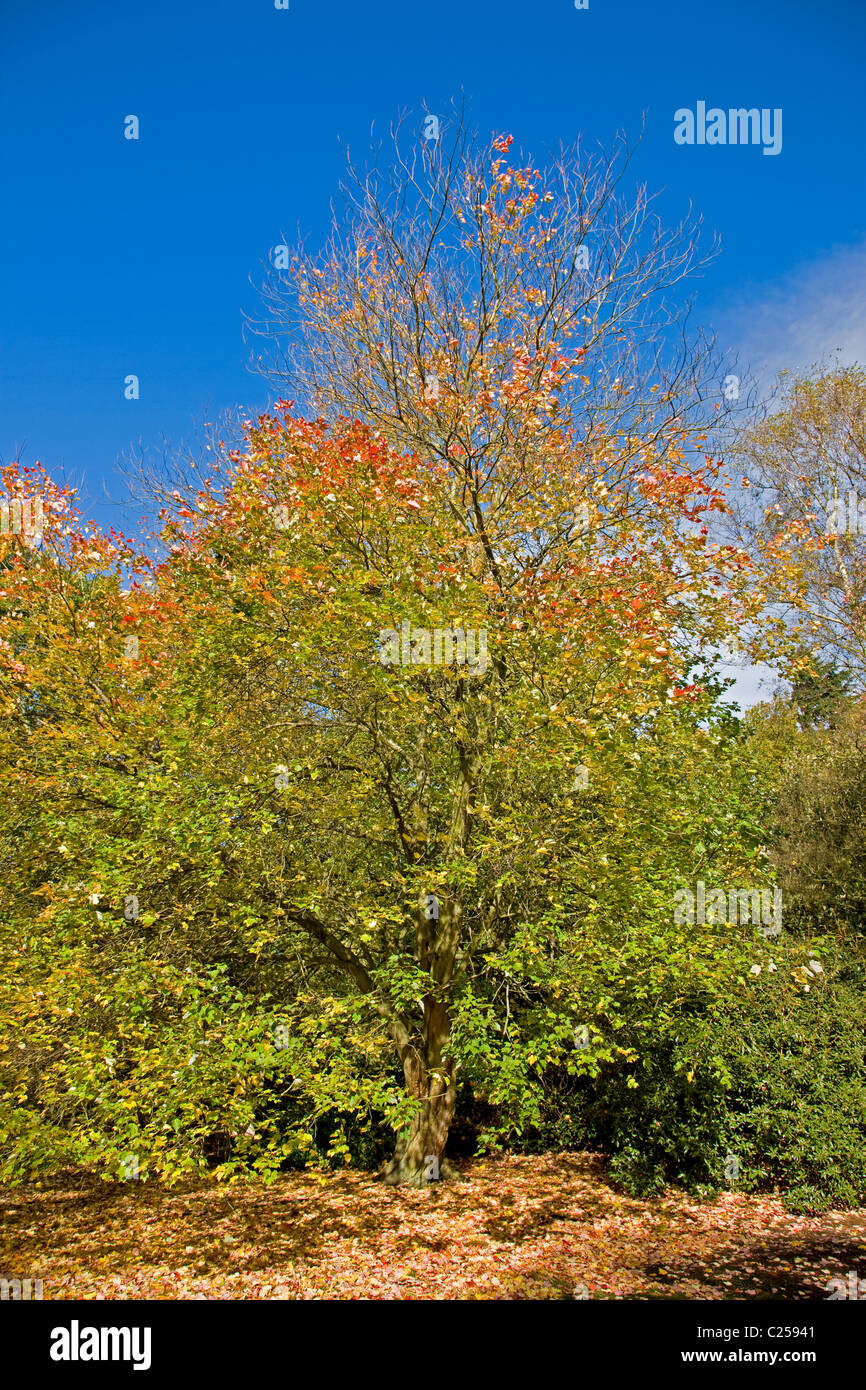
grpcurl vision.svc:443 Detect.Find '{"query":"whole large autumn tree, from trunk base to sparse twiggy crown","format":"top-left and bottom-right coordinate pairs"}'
top-left (3, 125), bottom-right (772, 1184)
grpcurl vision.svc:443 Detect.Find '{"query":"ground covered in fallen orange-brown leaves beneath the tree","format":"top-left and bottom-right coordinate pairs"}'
top-left (0, 1154), bottom-right (866, 1300)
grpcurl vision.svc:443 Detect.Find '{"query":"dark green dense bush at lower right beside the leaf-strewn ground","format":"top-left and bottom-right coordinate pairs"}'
top-left (521, 938), bottom-right (866, 1211)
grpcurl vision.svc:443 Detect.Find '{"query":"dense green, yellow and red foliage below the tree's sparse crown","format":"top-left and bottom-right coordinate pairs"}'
top-left (4, 389), bottom-right (753, 1179)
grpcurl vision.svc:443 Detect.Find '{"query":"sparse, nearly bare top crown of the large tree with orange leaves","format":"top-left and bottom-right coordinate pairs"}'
top-left (252, 113), bottom-right (727, 478)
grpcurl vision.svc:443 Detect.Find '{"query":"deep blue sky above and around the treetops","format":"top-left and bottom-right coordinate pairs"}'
top-left (0, 0), bottom-right (866, 695)
